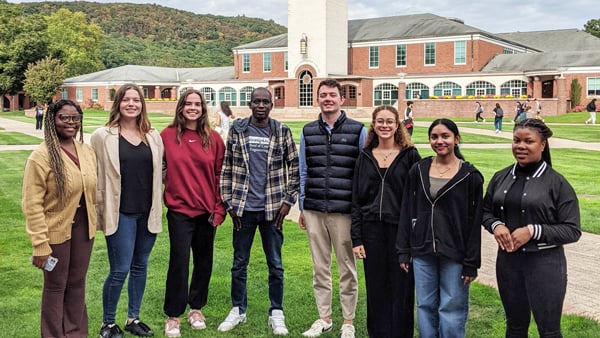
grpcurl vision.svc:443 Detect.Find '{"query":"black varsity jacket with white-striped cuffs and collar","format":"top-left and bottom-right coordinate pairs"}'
top-left (483, 161), bottom-right (581, 252)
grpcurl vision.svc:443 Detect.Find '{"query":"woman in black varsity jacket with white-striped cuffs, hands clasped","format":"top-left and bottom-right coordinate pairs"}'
top-left (483, 119), bottom-right (581, 338)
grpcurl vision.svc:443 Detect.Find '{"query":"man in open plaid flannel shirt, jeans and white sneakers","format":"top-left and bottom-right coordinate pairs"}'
top-left (218, 88), bottom-right (300, 335)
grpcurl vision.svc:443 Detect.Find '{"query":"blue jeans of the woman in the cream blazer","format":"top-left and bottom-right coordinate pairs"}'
top-left (102, 213), bottom-right (156, 324)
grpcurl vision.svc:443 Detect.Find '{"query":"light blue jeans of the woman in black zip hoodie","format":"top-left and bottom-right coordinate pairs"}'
top-left (413, 256), bottom-right (469, 338)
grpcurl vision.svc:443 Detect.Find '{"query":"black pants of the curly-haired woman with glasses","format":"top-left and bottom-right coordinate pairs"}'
top-left (362, 222), bottom-right (415, 338)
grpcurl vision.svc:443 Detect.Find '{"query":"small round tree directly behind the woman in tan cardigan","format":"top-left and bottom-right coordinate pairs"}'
top-left (23, 56), bottom-right (66, 103)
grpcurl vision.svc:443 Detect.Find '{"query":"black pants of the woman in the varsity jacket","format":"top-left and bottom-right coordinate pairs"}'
top-left (496, 247), bottom-right (567, 338)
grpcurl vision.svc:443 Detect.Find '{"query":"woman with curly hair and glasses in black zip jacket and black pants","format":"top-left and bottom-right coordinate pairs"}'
top-left (351, 106), bottom-right (421, 338)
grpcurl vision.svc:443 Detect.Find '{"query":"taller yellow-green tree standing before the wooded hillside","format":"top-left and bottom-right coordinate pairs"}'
top-left (46, 8), bottom-right (104, 77)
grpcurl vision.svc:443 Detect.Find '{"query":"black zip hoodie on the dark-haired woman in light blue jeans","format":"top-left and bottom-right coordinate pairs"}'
top-left (396, 157), bottom-right (483, 277)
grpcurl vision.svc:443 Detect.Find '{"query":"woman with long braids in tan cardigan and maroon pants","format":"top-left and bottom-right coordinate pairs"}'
top-left (22, 100), bottom-right (97, 337)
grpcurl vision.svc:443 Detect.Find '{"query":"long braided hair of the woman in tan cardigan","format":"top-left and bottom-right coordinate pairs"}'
top-left (44, 100), bottom-right (83, 204)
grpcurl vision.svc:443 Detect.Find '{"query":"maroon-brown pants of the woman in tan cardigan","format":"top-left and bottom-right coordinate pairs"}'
top-left (41, 213), bottom-right (94, 338)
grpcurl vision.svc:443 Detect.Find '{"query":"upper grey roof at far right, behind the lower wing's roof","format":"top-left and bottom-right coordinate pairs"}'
top-left (495, 29), bottom-right (600, 52)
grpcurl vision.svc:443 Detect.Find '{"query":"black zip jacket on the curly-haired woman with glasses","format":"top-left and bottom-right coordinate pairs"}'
top-left (351, 146), bottom-right (421, 247)
